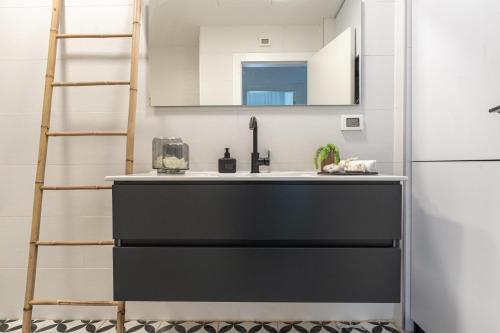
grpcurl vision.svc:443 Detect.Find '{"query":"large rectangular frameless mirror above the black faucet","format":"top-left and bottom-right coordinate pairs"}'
top-left (148, 0), bottom-right (361, 106)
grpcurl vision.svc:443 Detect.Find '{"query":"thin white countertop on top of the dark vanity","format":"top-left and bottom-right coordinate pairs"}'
top-left (105, 170), bottom-right (408, 182)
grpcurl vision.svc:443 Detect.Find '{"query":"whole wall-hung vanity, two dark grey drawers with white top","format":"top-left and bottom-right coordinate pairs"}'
top-left (107, 172), bottom-right (405, 303)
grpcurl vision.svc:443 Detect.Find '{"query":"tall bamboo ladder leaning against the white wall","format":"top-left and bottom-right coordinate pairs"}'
top-left (22, 0), bottom-right (141, 333)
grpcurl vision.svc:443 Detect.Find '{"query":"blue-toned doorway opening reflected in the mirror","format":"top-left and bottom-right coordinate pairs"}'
top-left (242, 61), bottom-right (307, 105)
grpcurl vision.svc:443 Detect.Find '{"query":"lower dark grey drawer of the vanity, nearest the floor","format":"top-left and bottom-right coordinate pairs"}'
top-left (113, 247), bottom-right (401, 303)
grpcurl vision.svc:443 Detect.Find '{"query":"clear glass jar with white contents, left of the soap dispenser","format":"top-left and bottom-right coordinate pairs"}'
top-left (153, 137), bottom-right (189, 174)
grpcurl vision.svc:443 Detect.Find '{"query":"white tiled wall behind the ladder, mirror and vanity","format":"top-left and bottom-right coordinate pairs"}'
top-left (0, 0), bottom-right (398, 320)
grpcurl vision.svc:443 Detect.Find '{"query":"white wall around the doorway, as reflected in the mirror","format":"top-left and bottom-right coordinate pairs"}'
top-left (200, 25), bottom-right (322, 105)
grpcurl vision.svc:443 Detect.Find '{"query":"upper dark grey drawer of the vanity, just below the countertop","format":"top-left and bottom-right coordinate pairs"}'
top-left (113, 182), bottom-right (401, 242)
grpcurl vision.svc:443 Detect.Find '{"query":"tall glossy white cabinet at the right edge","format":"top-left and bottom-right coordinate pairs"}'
top-left (410, 0), bottom-right (500, 333)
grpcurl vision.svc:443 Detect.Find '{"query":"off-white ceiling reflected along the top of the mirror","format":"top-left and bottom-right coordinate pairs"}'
top-left (148, 0), bottom-right (348, 47)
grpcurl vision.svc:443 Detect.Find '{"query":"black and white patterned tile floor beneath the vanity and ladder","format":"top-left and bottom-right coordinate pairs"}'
top-left (0, 320), bottom-right (402, 333)
